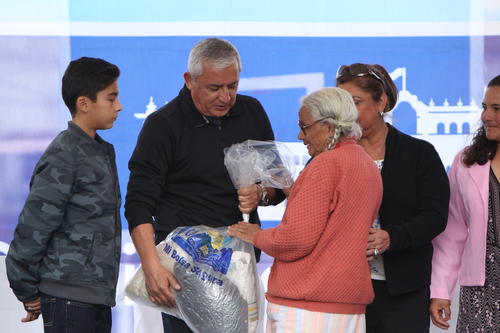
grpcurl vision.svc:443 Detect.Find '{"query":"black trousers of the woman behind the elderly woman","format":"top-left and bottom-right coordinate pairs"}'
top-left (366, 280), bottom-right (430, 333)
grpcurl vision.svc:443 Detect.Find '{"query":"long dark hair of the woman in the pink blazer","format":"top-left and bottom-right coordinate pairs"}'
top-left (462, 75), bottom-right (500, 167)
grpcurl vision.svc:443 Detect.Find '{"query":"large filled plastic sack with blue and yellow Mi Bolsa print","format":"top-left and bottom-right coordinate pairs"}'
top-left (125, 225), bottom-right (264, 333)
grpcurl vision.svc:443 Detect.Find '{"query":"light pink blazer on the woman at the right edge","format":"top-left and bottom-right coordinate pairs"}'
top-left (431, 151), bottom-right (490, 299)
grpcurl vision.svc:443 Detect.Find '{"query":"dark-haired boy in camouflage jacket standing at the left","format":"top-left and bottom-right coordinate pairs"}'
top-left (6, 57), bottom-right (122, 333)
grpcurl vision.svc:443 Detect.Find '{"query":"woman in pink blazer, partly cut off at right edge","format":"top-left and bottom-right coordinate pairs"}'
top-left (430, 75), bottom-right (500, 332)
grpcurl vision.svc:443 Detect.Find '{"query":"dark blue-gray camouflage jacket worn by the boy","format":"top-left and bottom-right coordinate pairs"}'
top-left (6, 122), bottom-right (121, 306)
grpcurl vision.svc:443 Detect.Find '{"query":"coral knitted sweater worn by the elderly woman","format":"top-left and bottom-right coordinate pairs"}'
top-left (254, 140), bottom-right (382, 314)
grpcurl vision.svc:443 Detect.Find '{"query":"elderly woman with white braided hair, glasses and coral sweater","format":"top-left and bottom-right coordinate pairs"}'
top-left (229, 88), bottom-right (382, 332)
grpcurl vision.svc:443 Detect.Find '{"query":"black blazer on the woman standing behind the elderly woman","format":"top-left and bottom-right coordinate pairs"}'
top-left (380, 125), bottom-right (450, 295)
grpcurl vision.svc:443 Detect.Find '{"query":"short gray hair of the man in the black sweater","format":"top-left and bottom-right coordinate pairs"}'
top-left (188, 38), bottom-right (241, 78)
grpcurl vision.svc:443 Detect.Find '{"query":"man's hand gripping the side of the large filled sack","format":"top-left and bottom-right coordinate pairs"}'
top-left (143, 263), bottom-right (181, 308)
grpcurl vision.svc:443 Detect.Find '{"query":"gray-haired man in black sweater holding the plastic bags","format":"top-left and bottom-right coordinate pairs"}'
top-left (125, 38), bottom-right (284, 332)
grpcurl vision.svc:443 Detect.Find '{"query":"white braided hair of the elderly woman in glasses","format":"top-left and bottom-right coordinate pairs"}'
top-left (301, 87), bottom-right (361, 149)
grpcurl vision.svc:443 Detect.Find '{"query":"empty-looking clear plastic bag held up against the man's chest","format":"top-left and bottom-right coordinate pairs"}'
top-left (224, 140), bottom-right (295, 189)
